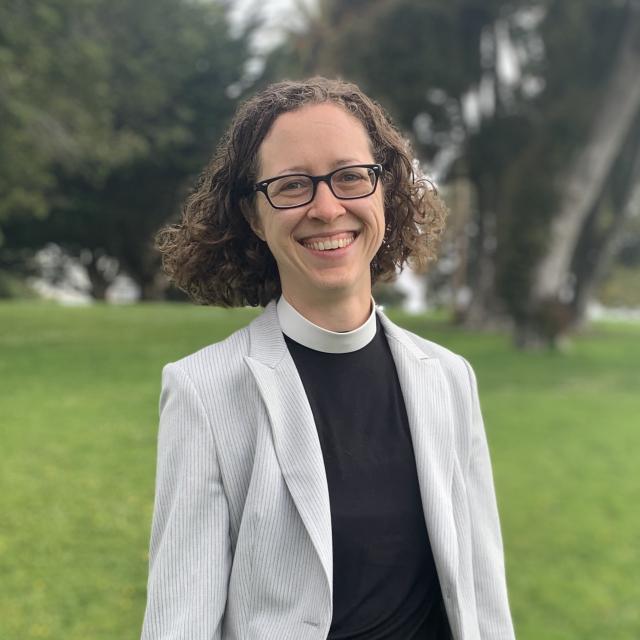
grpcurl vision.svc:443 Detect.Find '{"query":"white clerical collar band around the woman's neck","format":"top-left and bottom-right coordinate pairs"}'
top-left (276, 296), bottom-right (376, 353)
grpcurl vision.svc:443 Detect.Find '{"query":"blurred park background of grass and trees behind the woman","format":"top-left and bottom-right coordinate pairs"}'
top-left (0, 0), bottom-right (640, 640)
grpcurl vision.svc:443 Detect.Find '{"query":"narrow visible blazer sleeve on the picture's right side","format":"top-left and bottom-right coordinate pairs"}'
top-left (465, 360), bottom-right (515, 640)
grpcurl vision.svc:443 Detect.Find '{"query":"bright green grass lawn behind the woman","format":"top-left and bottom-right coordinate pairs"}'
top-left (0, 302), bottom-right (640, 640)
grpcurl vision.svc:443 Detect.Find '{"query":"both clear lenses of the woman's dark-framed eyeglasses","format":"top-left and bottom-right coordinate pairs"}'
top-left (267, 167), bottom-right (376, 207)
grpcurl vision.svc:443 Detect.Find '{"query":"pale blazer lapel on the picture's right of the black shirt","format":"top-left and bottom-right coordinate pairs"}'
top-left (378, 313), bottom-right (458, 590)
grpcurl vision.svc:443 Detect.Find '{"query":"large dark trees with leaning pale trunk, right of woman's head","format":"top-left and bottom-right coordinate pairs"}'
top-left (262, 0), bottom-right (640, 345)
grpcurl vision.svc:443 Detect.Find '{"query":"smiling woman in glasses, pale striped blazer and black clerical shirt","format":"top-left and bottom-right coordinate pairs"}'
top-left (142, 78), bottom-right (513, 640)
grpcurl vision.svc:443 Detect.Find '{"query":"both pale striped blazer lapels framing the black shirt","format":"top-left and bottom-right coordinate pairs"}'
top-left (245, 302), bottom-right (458, 601)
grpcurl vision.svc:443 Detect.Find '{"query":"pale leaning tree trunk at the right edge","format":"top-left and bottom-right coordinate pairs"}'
top-left (530, 3), bottom-right (640, 342)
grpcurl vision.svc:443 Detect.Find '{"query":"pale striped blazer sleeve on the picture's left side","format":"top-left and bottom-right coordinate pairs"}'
top-left (142, 363), bottom-right (231, 640)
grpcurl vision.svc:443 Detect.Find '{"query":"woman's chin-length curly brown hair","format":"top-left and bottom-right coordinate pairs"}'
top-left (156, 77), bottom-right (446, 307)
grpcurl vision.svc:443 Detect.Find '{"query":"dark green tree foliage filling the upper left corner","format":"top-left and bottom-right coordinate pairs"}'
top-left (0, 0), bottom-right (247, 296)
